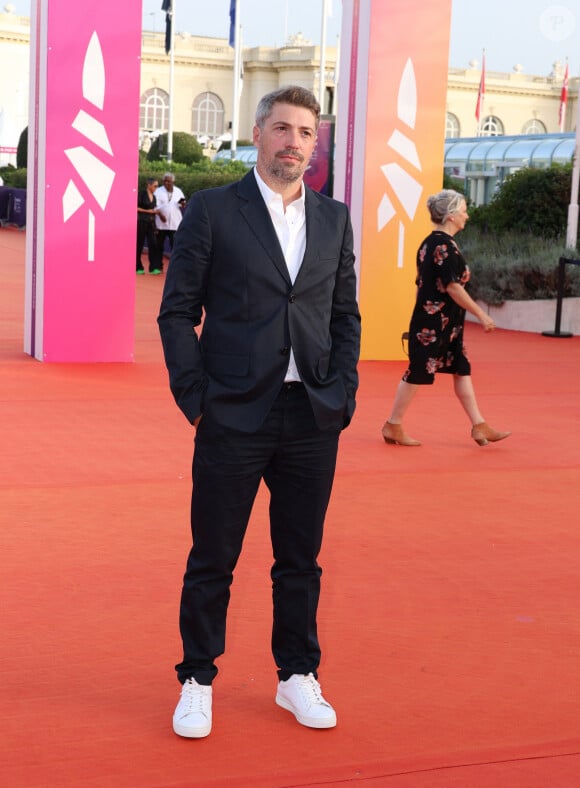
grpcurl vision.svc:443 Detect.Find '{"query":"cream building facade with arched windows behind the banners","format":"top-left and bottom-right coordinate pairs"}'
top-left (0, 7), bottom-right (580, 166)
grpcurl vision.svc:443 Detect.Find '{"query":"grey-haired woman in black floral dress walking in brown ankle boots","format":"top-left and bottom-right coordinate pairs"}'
top-left (383, 189), bottom-right (511, 446)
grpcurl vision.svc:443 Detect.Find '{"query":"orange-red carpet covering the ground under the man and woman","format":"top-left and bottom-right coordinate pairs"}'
top-left (0, 230), bottom-right (580, 788)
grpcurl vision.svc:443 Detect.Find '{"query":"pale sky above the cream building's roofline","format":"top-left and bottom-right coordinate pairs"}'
top-left (12, 0), bottom-right (580, 77)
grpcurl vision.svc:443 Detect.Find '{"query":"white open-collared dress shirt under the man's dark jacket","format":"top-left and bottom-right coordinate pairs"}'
top-left (254, 167), bottom-right (306, 383)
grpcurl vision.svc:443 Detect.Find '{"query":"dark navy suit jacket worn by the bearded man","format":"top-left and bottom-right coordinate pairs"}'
top-left (158, 172), bottom-right (360, 432)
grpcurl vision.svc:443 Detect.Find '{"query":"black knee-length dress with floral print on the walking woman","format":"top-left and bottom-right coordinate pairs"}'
top-left (403, 230), bottom-right (471, 385)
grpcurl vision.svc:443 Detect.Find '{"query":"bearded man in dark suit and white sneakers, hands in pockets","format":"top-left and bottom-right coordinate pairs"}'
top-left (159, 87), bottom-right (360, 738)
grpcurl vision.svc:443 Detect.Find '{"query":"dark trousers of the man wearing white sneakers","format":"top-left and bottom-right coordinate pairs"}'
top-left (176, 384), bottom-right (339, 684)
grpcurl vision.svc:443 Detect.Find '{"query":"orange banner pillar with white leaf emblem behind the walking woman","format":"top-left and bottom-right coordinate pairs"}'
top-left (337, 0), bottom-right (451, 360)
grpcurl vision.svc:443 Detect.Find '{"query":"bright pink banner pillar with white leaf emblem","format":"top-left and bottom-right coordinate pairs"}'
top-left (26, 0), bottom-right (142, 362)
